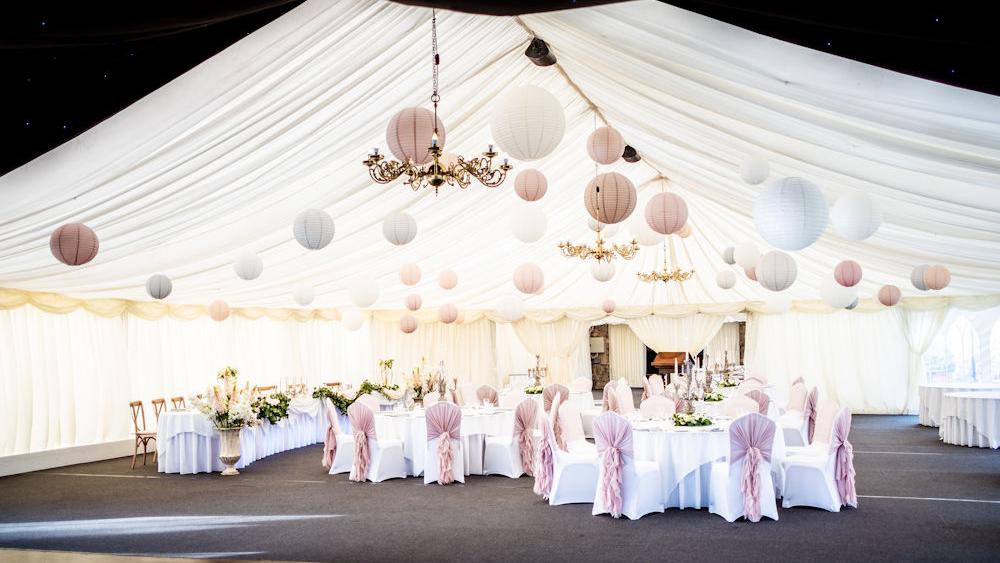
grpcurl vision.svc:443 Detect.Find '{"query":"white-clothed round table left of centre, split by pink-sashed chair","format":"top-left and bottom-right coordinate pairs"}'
top-left (375, 407), bottom-right (514, 477)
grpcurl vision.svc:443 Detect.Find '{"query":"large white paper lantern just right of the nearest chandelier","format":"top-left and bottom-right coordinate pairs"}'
top-left (490, 85), bottom-right (566, 161)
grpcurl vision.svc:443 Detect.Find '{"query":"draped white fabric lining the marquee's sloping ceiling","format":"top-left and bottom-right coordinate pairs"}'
top-left (0, 0), bottom-right (1000, 309)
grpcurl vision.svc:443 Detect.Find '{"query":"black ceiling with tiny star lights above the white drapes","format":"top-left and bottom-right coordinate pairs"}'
top-left (0, 0), bottom-right (1000, 173)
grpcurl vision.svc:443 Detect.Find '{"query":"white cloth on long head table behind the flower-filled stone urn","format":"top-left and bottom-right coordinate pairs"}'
top-left (156, 398), bottom-right (326, 474)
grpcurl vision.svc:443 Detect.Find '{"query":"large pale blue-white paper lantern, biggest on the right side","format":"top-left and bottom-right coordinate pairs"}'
top-left (753, 177), bottom-right (829, 250)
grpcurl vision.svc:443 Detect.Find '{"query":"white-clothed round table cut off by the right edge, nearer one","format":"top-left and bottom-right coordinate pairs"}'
top-left (938, 391), bottom-right (1000, 449)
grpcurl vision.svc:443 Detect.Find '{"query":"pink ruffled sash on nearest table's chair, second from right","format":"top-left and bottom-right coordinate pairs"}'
top-left (729, 413), bottom-right (775, 522)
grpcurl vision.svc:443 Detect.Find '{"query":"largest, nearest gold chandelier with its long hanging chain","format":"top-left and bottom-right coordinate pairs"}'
top-left (362, 11), bottom-right (513, 194)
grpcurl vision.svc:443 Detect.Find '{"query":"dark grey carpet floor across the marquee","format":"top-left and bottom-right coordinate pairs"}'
top-left (0, 416), bottom-right (1000, 562)
